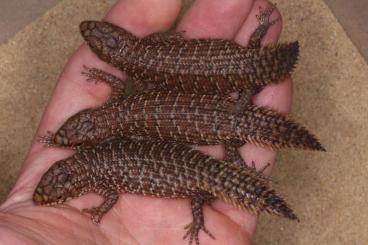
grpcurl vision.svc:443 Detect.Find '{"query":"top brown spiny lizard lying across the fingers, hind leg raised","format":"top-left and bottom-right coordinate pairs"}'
top-left (80, 5), bottom-right (299, 97)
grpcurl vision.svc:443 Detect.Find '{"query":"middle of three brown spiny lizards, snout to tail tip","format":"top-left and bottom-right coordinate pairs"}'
top-left (41, 91), bottom-right (324, 150)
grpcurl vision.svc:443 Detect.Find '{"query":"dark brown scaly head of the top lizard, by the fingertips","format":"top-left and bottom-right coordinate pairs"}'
top-left (80, 21), bottom-right (137, 65)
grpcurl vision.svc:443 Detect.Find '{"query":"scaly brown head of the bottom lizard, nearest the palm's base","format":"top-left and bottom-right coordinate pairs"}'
top-left (33, 160), bottom-right (79, 206)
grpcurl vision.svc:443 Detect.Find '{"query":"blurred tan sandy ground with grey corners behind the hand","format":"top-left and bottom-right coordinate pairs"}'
top-left (0, 0), bottom-right (368, 245)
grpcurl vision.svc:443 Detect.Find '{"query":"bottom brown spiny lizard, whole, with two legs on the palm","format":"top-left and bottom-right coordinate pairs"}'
top-left (33, 138), bottom-right (298, 245)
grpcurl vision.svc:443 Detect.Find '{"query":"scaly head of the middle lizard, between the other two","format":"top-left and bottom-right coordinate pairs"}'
top-left (39, 109), bottom-right (102, 147)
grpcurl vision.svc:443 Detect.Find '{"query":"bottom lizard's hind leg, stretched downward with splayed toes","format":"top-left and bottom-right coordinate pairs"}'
top-left (183, 192), bottom-right (215, 245)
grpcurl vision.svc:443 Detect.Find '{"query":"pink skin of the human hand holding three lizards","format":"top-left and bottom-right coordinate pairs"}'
top-left (0, 0), bottom-right (292, 245)
